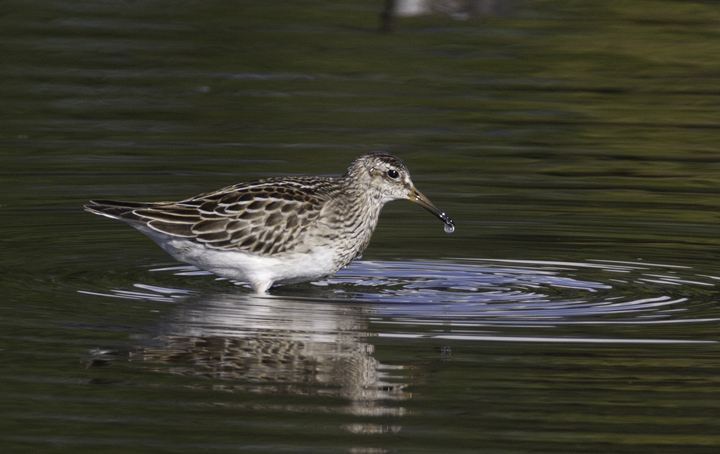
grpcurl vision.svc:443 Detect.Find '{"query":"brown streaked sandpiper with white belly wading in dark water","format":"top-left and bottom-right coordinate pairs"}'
top-left (85, 151), bottom-right (455, 294)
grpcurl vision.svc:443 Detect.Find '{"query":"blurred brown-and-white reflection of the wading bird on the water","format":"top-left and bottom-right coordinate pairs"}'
top-left (109, 295), bottom-right (408, 414)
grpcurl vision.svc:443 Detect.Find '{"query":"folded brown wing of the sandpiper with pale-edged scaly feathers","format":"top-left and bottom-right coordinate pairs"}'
top-left (86, 178), bottom-right (326, 255)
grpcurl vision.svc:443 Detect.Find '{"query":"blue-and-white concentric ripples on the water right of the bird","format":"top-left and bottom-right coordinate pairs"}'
top-left (316, 259), bottom-right (717, 324)
